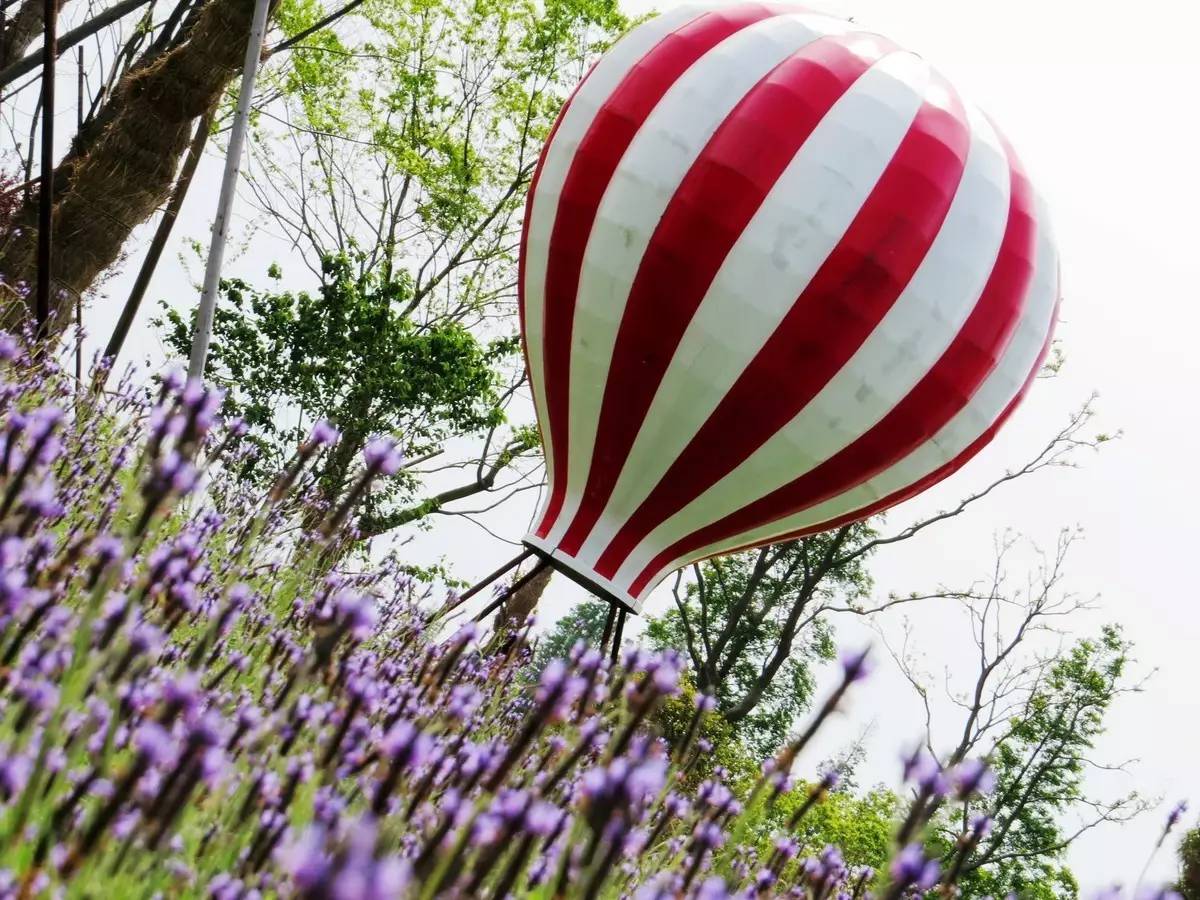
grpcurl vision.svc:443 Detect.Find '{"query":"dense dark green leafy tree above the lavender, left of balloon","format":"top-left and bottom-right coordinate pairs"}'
top-left (161, 257), bottom-right (535, 538)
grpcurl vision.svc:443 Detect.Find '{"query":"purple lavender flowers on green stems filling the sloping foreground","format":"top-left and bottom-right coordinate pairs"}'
top-left (0, 335), bottom-right (1185, 900)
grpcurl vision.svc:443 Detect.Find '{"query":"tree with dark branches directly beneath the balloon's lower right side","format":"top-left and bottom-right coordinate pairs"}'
top-left (648, 401), bottom-right (1109, 755)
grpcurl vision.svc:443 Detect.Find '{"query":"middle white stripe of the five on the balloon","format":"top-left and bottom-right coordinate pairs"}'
top-left (578, 53), bottom-right (928, 560)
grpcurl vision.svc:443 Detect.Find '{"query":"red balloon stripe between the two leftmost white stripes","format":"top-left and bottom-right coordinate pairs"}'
top-left (536, 4), bottom-right (779, 538)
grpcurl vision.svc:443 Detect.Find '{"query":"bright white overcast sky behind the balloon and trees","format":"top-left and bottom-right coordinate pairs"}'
top-left (60, 0), bottom-right (1200, 888)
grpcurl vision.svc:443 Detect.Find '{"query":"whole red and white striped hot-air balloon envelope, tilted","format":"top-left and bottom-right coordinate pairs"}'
top-left (520, 2), bottom-right (1058, 611)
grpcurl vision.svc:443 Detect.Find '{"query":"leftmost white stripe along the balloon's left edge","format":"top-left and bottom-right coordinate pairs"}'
top-left (522, 5), bottom-right (706, 521)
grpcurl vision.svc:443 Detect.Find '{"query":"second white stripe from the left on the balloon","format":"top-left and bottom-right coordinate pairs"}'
top-left (548, 14), bottom-right (848, 544)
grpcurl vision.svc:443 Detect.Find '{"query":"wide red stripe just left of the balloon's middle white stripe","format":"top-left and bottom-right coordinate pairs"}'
top-left (559, 35), bottom-right (893, 556)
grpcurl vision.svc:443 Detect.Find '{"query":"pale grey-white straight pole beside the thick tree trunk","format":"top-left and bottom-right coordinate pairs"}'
top-left (187, 0), bottom-right (270, 379)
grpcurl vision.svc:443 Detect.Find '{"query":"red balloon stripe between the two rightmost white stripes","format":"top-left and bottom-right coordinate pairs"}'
top-left (628, 123), bottom-right (1037, 595)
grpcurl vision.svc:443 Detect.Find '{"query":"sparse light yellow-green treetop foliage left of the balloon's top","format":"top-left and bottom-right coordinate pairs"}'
top-left (251, 0), bottom-right (628, 289)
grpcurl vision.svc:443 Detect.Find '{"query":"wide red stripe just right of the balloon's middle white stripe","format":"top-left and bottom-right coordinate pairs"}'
top-left (596, 84), bottom-right (970, 577)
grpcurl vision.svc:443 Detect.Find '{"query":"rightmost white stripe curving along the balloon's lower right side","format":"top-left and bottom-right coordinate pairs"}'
top-left (628, 190), bottom-right (1060, 599)
